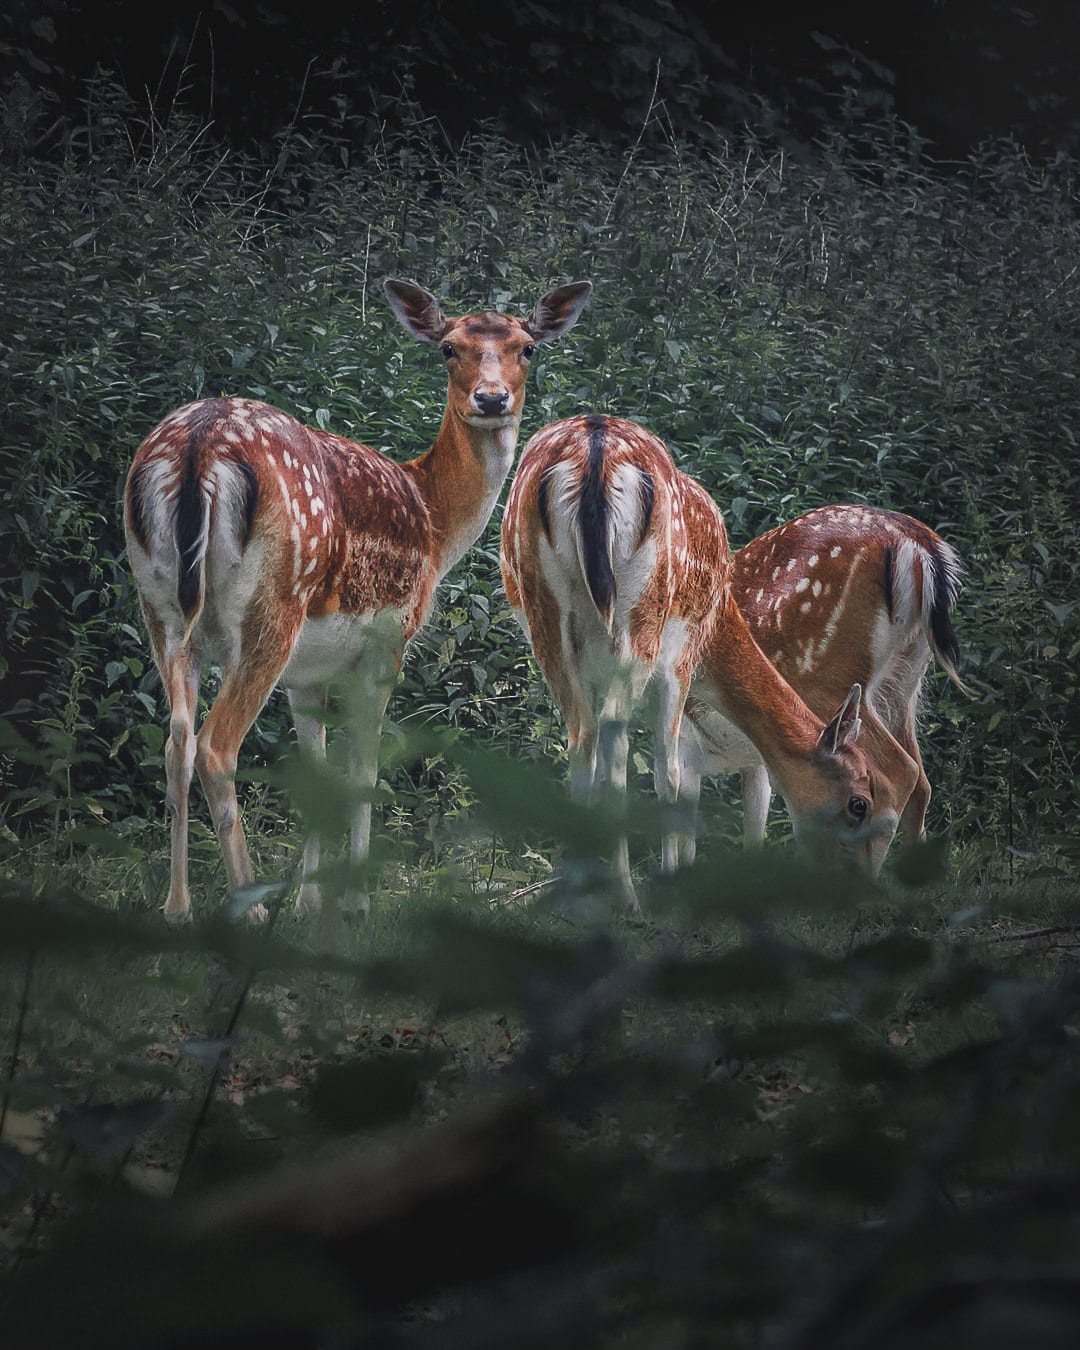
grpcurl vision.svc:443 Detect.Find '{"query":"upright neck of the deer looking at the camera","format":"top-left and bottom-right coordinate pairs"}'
top-left (402, 408), bottom-right (518, 578)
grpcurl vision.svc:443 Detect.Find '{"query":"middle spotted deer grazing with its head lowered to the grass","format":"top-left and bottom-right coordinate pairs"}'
top-left (500, 413), bottom-right (917, 910)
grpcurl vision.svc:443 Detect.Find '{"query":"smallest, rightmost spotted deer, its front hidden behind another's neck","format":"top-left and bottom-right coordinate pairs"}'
top-left (680, 505), bottom-right (967, 873)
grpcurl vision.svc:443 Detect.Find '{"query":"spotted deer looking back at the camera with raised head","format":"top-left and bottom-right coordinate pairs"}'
top-left (124, 278), bottom-right (591, 922)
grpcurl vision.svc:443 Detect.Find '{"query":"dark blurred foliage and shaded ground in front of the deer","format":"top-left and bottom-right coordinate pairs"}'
top-left (0, 815), bottom-right (1080, 1350)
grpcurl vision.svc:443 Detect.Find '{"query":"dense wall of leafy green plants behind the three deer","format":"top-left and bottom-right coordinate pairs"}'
top-left (0, 82), bottom-right (1080, 849)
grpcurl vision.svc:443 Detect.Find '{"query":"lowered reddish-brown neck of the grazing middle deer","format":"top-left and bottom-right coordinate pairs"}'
top-left (694, 590), bottom-right (825, 792)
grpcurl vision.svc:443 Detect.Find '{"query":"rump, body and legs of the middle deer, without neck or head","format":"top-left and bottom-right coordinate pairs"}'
top-left (500, 416), bottom-right (729, 909)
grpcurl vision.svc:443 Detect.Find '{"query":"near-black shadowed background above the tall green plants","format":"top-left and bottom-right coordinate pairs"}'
top-left (0, 0), bottom-right (1080, 159)
